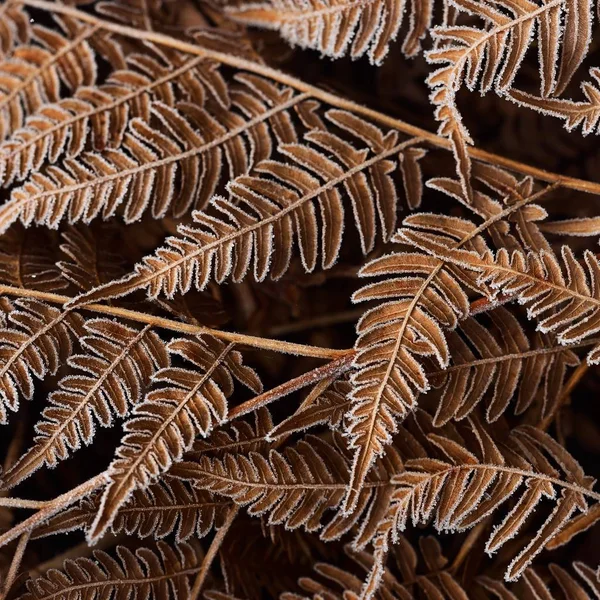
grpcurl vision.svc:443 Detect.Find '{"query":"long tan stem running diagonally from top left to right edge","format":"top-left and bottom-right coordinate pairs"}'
top-left (18, 0), bottom-right (600, 194)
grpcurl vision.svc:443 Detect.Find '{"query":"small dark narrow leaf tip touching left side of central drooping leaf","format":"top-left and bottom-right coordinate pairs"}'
top-left (268, 381), bottom-right (352, 440)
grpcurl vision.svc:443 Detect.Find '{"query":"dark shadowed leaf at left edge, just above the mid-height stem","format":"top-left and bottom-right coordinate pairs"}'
top-left (0, 225), bottom-right (68, 293)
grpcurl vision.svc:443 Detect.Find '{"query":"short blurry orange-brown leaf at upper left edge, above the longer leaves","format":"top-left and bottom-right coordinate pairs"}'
top-left (0, 16), bottom-right (96, 141)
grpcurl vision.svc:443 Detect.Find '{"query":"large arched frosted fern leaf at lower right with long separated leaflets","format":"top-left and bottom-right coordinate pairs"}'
top-left (388, 421), bottom-right (600, 581)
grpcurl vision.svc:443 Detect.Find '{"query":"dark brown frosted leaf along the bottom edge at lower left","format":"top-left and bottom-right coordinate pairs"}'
top-left (20, 541), bottom-right (201, 600)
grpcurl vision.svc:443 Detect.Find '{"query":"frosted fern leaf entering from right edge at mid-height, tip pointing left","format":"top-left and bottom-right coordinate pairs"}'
top-left (398, 215), bottom-right (600, 364)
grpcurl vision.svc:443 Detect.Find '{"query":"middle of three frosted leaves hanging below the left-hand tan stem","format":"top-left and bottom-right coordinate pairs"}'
top-left (3, 319), bottom-right (169, 487)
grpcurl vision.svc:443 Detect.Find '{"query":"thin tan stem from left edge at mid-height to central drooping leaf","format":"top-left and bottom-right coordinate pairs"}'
top-left (0, 285), bottom-right (348, 358)
